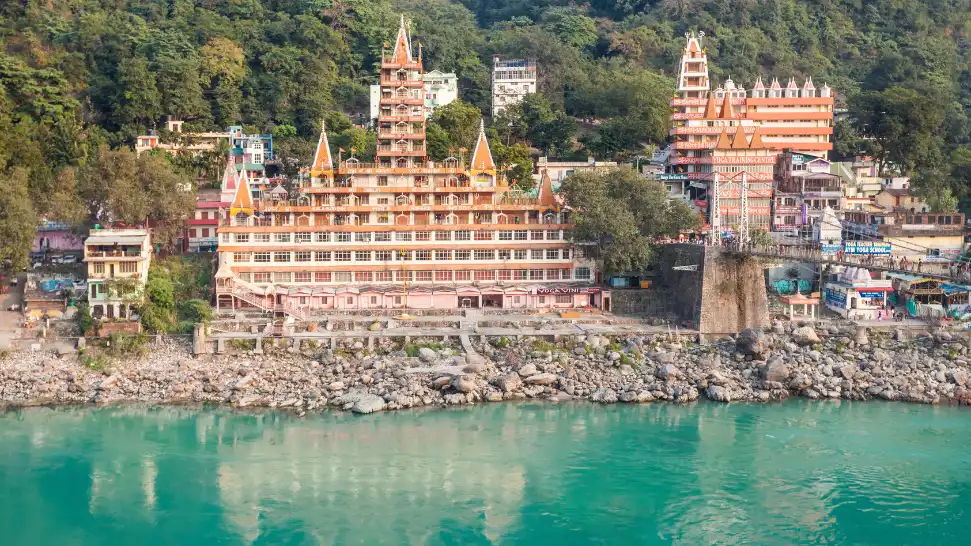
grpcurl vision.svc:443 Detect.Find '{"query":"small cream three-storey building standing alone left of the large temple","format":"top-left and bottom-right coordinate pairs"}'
top-left (84, 229), bottom-right (152, 318)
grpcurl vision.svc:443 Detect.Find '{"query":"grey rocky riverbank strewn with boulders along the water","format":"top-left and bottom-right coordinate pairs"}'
top-left (0, 323), bottom-right (971, 413)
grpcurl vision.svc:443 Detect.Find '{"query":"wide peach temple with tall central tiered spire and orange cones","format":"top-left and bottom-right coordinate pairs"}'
top-left (216, 20), bottom-right (609, 317)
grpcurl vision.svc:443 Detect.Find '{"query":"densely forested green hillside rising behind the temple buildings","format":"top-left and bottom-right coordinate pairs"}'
top-left (0, 0), bottom-right (971, 266)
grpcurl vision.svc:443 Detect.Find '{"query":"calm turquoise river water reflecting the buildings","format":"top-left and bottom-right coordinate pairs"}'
top-left (0, 401), bottom-right (971, 546)
